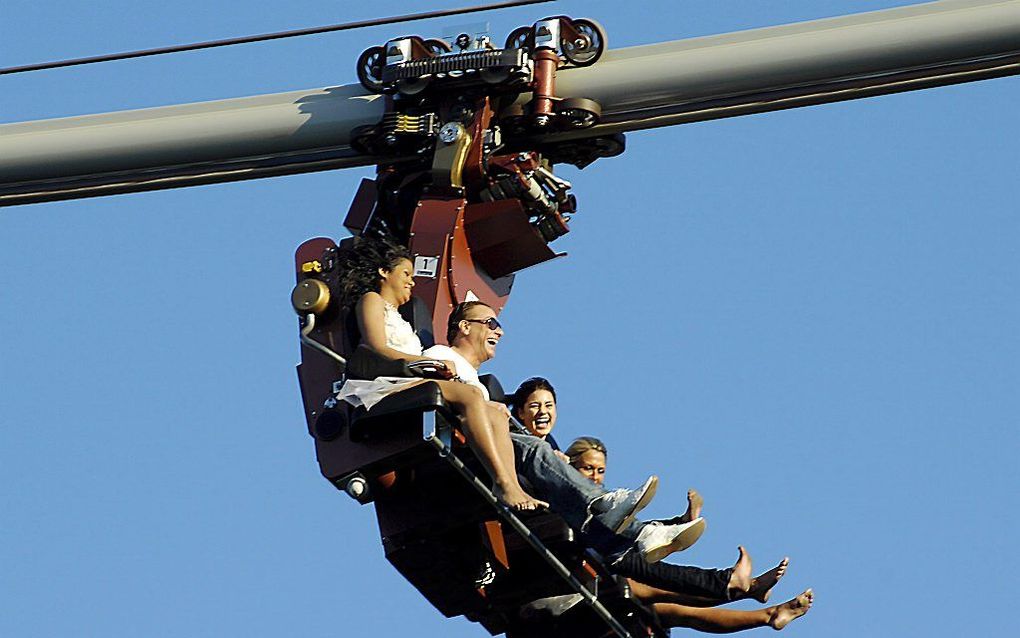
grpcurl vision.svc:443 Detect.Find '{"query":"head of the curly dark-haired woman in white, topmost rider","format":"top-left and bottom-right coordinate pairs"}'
top-left (337, 237), bottom-right (414, 305)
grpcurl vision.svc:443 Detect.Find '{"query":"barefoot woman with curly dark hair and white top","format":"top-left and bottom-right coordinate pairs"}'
top-left (337, 238), bottom-right (546, 510)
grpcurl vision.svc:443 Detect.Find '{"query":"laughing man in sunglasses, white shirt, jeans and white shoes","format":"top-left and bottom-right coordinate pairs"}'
top-left (422, 301), bottom-right (705, 562)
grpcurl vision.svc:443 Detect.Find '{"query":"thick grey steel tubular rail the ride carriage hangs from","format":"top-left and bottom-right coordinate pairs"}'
top-left (0, 0), bottom-right (1020, 205)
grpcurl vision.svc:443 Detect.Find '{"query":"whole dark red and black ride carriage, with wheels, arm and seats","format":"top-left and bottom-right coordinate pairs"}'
top-left (292, 16), bottom-right (667, 637)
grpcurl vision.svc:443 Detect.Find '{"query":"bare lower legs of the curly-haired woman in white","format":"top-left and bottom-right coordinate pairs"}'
top-left (437, 381), bottom-right (543, 510)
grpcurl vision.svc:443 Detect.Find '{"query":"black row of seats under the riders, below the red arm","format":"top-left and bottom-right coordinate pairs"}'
top-left (298, 234), bottom-right (665, 635)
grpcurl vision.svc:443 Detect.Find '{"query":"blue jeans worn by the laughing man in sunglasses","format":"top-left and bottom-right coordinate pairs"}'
top-left (510, 432), bottom-right (640, 555)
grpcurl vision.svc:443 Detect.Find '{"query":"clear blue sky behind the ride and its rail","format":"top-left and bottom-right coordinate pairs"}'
top-left (0, 0), bottom-right (1020, 638)
